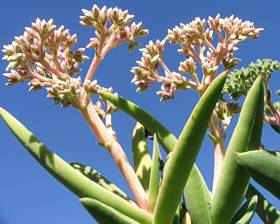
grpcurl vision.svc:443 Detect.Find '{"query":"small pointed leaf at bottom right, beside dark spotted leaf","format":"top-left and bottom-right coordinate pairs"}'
top-left (231, 195), bottom-right (258, 224)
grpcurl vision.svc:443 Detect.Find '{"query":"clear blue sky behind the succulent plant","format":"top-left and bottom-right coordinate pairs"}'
top-left (0, 0), bottom-right (280, 224)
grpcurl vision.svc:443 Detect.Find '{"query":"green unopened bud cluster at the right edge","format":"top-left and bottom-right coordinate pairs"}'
top-left (223, 59), bottom-right (280, 100)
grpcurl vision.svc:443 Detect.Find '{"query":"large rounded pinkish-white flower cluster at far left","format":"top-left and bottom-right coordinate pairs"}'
top-left (3, 19), bottom-right (87, 90)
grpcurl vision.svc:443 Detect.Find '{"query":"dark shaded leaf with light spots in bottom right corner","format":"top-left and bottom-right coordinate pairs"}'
top-left (246, 184), bottom-right (280, 224)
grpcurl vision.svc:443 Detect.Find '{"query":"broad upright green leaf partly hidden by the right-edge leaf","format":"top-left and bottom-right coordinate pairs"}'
top-left (211, 77), bottom-right (264, 224)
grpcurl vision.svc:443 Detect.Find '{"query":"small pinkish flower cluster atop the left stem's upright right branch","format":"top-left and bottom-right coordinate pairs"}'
top-left (80, 5), bottom-right (148, 53)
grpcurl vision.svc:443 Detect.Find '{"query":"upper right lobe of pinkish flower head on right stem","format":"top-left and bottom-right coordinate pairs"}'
top-left (167, 14), bottom-right (263, 71)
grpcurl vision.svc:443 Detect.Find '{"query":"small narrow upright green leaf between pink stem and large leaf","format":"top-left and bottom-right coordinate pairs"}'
top-left (148, 134), bottom-right (160, 213)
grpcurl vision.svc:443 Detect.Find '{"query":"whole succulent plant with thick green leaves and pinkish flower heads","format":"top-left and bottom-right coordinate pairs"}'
top-left (0, 5), bottom-right (280, 224)
